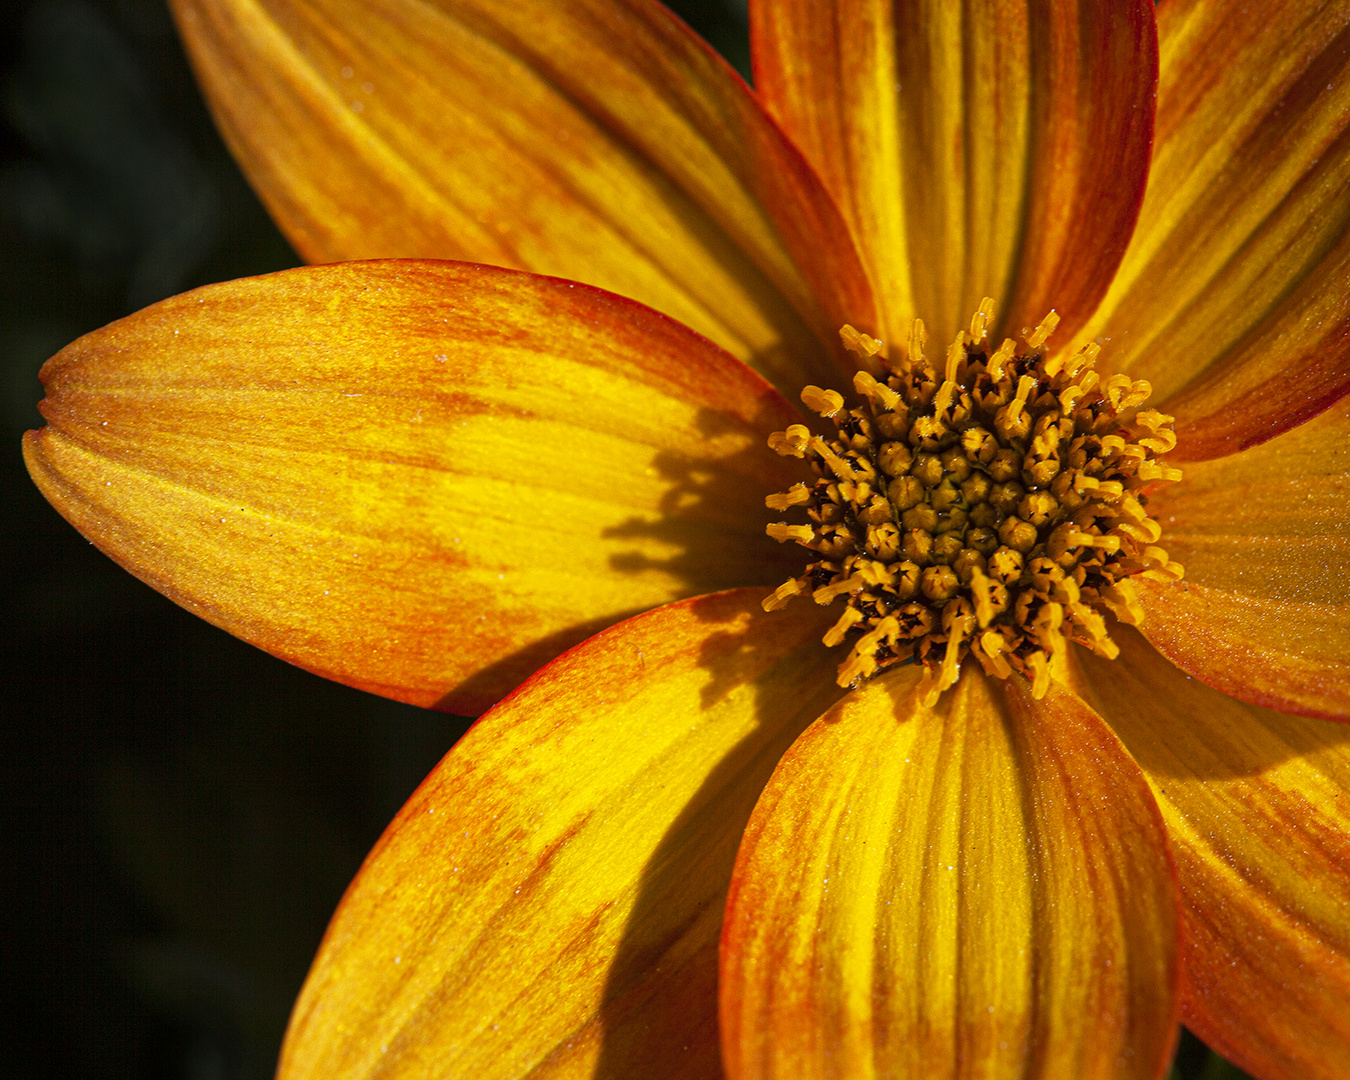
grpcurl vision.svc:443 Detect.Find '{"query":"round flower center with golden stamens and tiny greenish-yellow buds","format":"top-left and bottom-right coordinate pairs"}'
top-left (764, 298), bottom-right (1183, 703)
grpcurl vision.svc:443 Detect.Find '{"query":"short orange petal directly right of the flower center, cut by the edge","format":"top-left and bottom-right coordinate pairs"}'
top-left (1141, 398), bottom-right (1350, 720)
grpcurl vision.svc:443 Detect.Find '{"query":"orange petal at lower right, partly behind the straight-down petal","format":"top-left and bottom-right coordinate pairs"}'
top-left (1079, 628), bottom-right (1350, 1080)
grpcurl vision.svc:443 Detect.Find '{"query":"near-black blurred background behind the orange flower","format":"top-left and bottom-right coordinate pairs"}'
top-left (0, 0), bottom-right (1238, 1080)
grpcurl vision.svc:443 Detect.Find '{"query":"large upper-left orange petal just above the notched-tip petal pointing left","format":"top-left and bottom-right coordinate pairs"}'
top-left (174, 0), bottom-right (872, 393)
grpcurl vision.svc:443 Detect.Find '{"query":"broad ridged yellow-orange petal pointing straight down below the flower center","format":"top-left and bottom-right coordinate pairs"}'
top-left (721, 670), bottom-right (1176, 1080)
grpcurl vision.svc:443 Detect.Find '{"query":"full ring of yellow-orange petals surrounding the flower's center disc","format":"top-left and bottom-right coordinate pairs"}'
top-left (18, 0), bottom-right (1350, 1077)
